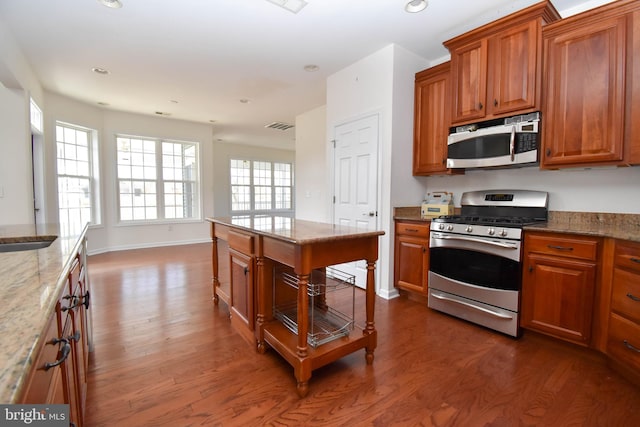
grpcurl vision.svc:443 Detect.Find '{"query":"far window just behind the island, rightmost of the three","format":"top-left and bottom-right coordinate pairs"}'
top-left (230, 159), bottom-right (293, 212)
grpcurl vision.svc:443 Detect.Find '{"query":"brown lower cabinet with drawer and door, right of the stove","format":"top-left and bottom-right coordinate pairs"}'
top-left (521, 233), bottom-right (600, 346)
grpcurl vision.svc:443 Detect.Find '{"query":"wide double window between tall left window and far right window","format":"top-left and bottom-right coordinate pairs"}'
top-left (116, 136), bottom-right (200, 221)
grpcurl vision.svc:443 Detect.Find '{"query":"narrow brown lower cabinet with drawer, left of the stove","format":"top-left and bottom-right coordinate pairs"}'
top-left (394, 221), bottom-right (430, 296)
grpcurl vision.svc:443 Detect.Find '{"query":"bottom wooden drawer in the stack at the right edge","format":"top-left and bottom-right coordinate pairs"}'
top-left (607, 313), bottom-right (640, 370)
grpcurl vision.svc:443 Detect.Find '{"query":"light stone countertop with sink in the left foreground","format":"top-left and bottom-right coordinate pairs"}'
top-left (0, 225), bottom-right (87, 404)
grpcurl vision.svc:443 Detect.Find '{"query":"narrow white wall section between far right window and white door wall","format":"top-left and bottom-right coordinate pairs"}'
top-left (295, 106), bottom-right (331, 222)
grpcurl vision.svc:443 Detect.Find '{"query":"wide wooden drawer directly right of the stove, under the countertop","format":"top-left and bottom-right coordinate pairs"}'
top-left (525, 234), bottom-right (598, 261)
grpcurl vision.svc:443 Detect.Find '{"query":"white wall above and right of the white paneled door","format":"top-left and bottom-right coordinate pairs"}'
top-left (324, 45), bottom-right (428, 298)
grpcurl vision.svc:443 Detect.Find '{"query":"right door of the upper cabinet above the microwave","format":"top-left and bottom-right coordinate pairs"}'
top-left (487, 21), bottom-right (541, 115)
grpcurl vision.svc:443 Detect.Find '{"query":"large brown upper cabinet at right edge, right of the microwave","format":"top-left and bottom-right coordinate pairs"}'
top-left (540, 1), bottom-right (640, 169)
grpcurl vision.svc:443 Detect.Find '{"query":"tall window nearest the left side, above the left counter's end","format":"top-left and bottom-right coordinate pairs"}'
top-left (56, 122), bottom-right (100, 235)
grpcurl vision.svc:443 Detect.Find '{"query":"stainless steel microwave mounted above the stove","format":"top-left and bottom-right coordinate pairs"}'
top-left (447, 112), bottom-right (540, 169)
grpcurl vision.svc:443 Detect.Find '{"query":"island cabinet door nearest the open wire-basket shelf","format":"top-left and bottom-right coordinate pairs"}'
top-left (229, 249), bottom-right (255, 330)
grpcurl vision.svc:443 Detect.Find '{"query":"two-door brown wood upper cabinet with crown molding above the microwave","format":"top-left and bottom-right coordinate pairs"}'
top-left (444, 1), bottom-right (560, 124)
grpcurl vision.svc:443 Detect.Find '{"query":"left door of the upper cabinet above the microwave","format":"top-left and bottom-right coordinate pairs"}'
top-left (451, 39), bottom-right (488, 123)
